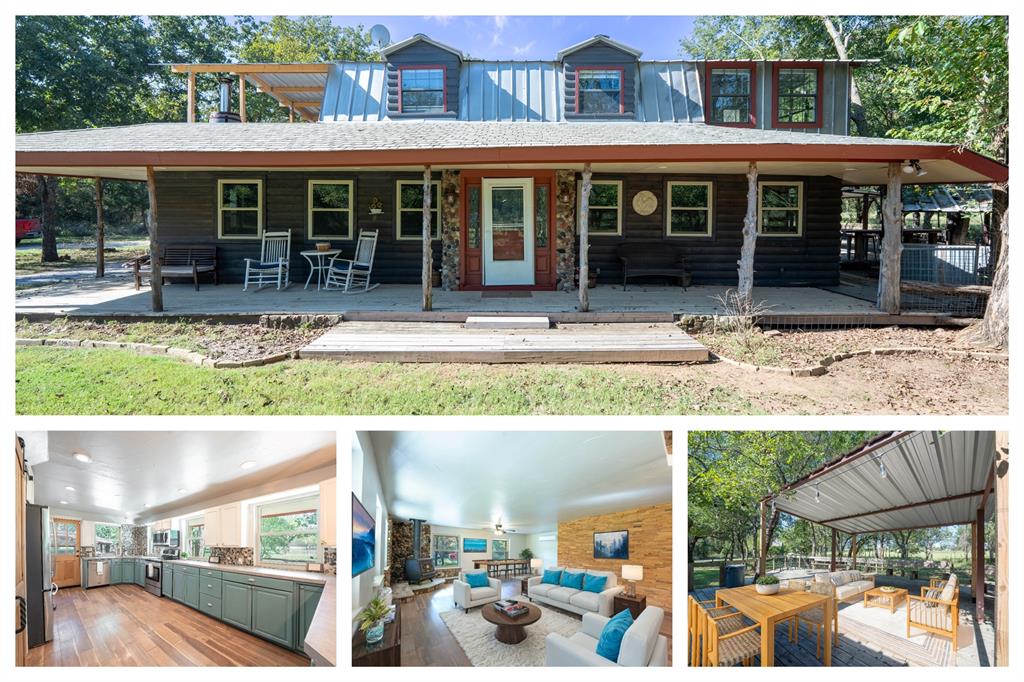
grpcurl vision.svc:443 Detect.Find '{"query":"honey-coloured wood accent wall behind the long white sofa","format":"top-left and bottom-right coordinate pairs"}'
top-left (558, 502), bottom-right (672, 613)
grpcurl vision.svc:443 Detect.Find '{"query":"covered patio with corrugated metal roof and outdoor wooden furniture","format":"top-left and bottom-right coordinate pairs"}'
top-left (691, 431), bottom-right (1010, 666)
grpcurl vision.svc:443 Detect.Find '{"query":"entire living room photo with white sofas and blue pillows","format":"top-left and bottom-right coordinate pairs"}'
top-left (352, 431), bottom-right (672, 667)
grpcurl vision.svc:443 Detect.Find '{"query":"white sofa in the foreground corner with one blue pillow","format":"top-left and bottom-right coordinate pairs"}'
top-left (544, 606), bottom-right (669, 668)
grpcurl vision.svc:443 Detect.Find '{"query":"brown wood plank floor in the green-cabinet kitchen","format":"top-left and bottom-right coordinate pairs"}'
top-left (26, 585), bottom-right (309, 666)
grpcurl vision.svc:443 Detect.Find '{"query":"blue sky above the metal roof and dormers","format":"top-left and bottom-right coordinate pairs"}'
top-left (334, 16), bottom-right (693, 59)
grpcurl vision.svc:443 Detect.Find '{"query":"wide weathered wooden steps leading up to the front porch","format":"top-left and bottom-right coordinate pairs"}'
top-left (299, 322), bottom-right (708, 364)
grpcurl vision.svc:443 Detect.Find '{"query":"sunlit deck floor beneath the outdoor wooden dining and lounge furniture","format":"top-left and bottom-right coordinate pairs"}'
top-left (690, 576), bottom-right (995, 667)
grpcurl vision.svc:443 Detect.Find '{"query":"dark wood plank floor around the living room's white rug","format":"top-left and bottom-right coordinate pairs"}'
top-left (401, 580), bottom-right (672, 667)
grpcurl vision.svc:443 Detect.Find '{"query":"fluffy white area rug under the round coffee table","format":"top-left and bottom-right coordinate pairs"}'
top-left (441, 604), bottom-right (583, 668)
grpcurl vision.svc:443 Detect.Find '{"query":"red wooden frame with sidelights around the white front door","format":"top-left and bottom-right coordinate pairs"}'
top-left (459, 170), bottom-right (558, 291)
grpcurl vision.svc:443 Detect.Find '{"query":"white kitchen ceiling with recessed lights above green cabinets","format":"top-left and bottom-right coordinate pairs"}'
top-left (19, 431), bottom-right (335, 521)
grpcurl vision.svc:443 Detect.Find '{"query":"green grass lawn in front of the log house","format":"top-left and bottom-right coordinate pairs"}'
top-left (15, 346), bottom-right (754, 415)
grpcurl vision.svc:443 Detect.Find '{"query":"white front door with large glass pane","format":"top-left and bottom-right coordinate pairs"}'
top-left (481, 177), bottom-right (535, 287)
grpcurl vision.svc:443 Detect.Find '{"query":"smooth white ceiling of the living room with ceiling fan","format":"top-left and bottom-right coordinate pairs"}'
top-left (370, 431), bottom-right (672, 532)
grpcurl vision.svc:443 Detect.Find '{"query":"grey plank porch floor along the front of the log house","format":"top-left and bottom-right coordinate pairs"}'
top-left (15, 279), bottom-right (891, 322)
